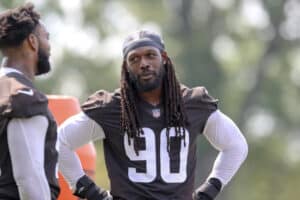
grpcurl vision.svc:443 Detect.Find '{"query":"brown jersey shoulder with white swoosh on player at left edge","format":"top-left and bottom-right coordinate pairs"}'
top-left (0, 76), bottom-right (48, 117)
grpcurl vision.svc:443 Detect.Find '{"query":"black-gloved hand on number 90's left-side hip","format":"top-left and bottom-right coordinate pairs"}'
top-left (74, 175), bottom-right (112, 200)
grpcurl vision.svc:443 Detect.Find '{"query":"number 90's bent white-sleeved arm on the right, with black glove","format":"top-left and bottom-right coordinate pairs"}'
top-left (195, 110), bottom-right (248, 199)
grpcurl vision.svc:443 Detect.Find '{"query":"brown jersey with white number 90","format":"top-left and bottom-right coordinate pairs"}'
top-left (82, 87), bottom-right (217, 200)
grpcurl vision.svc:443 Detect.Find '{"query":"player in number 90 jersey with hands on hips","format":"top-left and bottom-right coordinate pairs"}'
top-left (59, 30), bottom-right (248, 200)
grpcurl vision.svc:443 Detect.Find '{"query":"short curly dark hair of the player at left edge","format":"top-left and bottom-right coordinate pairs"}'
top-left (0, 3), bottom-right (40, 49)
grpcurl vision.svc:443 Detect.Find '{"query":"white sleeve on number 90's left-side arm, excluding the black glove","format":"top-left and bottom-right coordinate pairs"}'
top-left (58, 112), bottom-right (105, 190)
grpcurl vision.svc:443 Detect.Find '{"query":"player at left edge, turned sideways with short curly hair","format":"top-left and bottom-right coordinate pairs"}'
top-left (0, 3), bottom-right (60, 200)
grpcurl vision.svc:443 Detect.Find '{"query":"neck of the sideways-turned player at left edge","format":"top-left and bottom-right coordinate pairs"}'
top-left (1, 56), bottom-right (35, 81)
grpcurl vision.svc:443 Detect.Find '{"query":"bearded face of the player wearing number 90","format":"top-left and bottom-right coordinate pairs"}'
top-left (126, 46), bottom-right (165, 92)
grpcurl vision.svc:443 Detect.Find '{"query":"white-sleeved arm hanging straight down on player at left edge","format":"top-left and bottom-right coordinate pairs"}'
top-left (7, 116), bottom-right (51, 200)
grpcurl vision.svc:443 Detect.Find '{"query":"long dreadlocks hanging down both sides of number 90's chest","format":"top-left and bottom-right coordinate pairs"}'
top-left (121, 54), bottom-right (187, 155)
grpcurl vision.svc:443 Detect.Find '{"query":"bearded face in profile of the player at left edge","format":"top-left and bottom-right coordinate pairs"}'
top-left (36, 25), bottom-right (51, 75)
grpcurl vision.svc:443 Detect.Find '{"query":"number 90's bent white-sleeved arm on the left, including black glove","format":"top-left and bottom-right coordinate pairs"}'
top-left (58, 112), bottom-right (109, 200)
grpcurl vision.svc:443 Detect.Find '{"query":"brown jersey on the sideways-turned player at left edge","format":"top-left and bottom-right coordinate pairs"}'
top-left (0, 73), bottom-right (60, 200)
